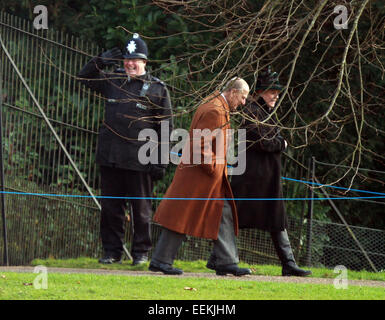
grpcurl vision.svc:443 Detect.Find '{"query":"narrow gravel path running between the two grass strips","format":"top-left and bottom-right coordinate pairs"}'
top-left (0, 267), bottom-right (385, 289)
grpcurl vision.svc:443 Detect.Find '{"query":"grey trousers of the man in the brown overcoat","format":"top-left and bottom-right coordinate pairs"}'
top-left (152, 200), bottom-right (239, 266)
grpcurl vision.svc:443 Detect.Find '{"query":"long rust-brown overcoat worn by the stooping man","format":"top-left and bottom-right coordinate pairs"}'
top-left (154, 92), bottom-right (238, 240)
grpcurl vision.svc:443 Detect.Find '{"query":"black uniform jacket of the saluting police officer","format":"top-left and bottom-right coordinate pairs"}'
top-left (78, 57), bottom-right (172, 171)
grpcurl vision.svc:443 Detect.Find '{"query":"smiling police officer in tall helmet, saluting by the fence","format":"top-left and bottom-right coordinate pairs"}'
top-left (78, 34), bottom-right (172, 265)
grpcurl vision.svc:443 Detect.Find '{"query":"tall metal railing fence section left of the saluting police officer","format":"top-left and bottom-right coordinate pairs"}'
top-left (0, 12), bottom-right (103, 265)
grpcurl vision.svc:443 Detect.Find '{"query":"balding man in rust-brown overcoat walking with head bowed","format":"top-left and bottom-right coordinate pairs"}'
top-left (149, 78), bottom-right (251, 276)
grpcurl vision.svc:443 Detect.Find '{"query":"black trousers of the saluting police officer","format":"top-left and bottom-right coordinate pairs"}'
top-left (100, 166), bottom-right (153, 259)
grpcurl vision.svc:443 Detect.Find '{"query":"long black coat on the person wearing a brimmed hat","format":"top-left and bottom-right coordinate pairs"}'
top-left (231, 98), bottom-right (287, 231)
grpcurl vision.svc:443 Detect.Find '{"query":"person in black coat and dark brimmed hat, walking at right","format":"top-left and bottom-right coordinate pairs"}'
top-left (231, 67), bottom-right (311, 276)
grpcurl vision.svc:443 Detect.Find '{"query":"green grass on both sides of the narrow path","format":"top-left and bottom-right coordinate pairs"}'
top-left (0, 258), bottom-right (385, 300)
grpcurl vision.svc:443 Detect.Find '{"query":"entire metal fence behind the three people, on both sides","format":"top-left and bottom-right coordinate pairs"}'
top-left (0, 13), bottom-right (385, 270)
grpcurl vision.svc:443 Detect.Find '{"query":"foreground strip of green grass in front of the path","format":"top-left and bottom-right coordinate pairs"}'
top-left (0, 272), bottom-right (384, 300)
